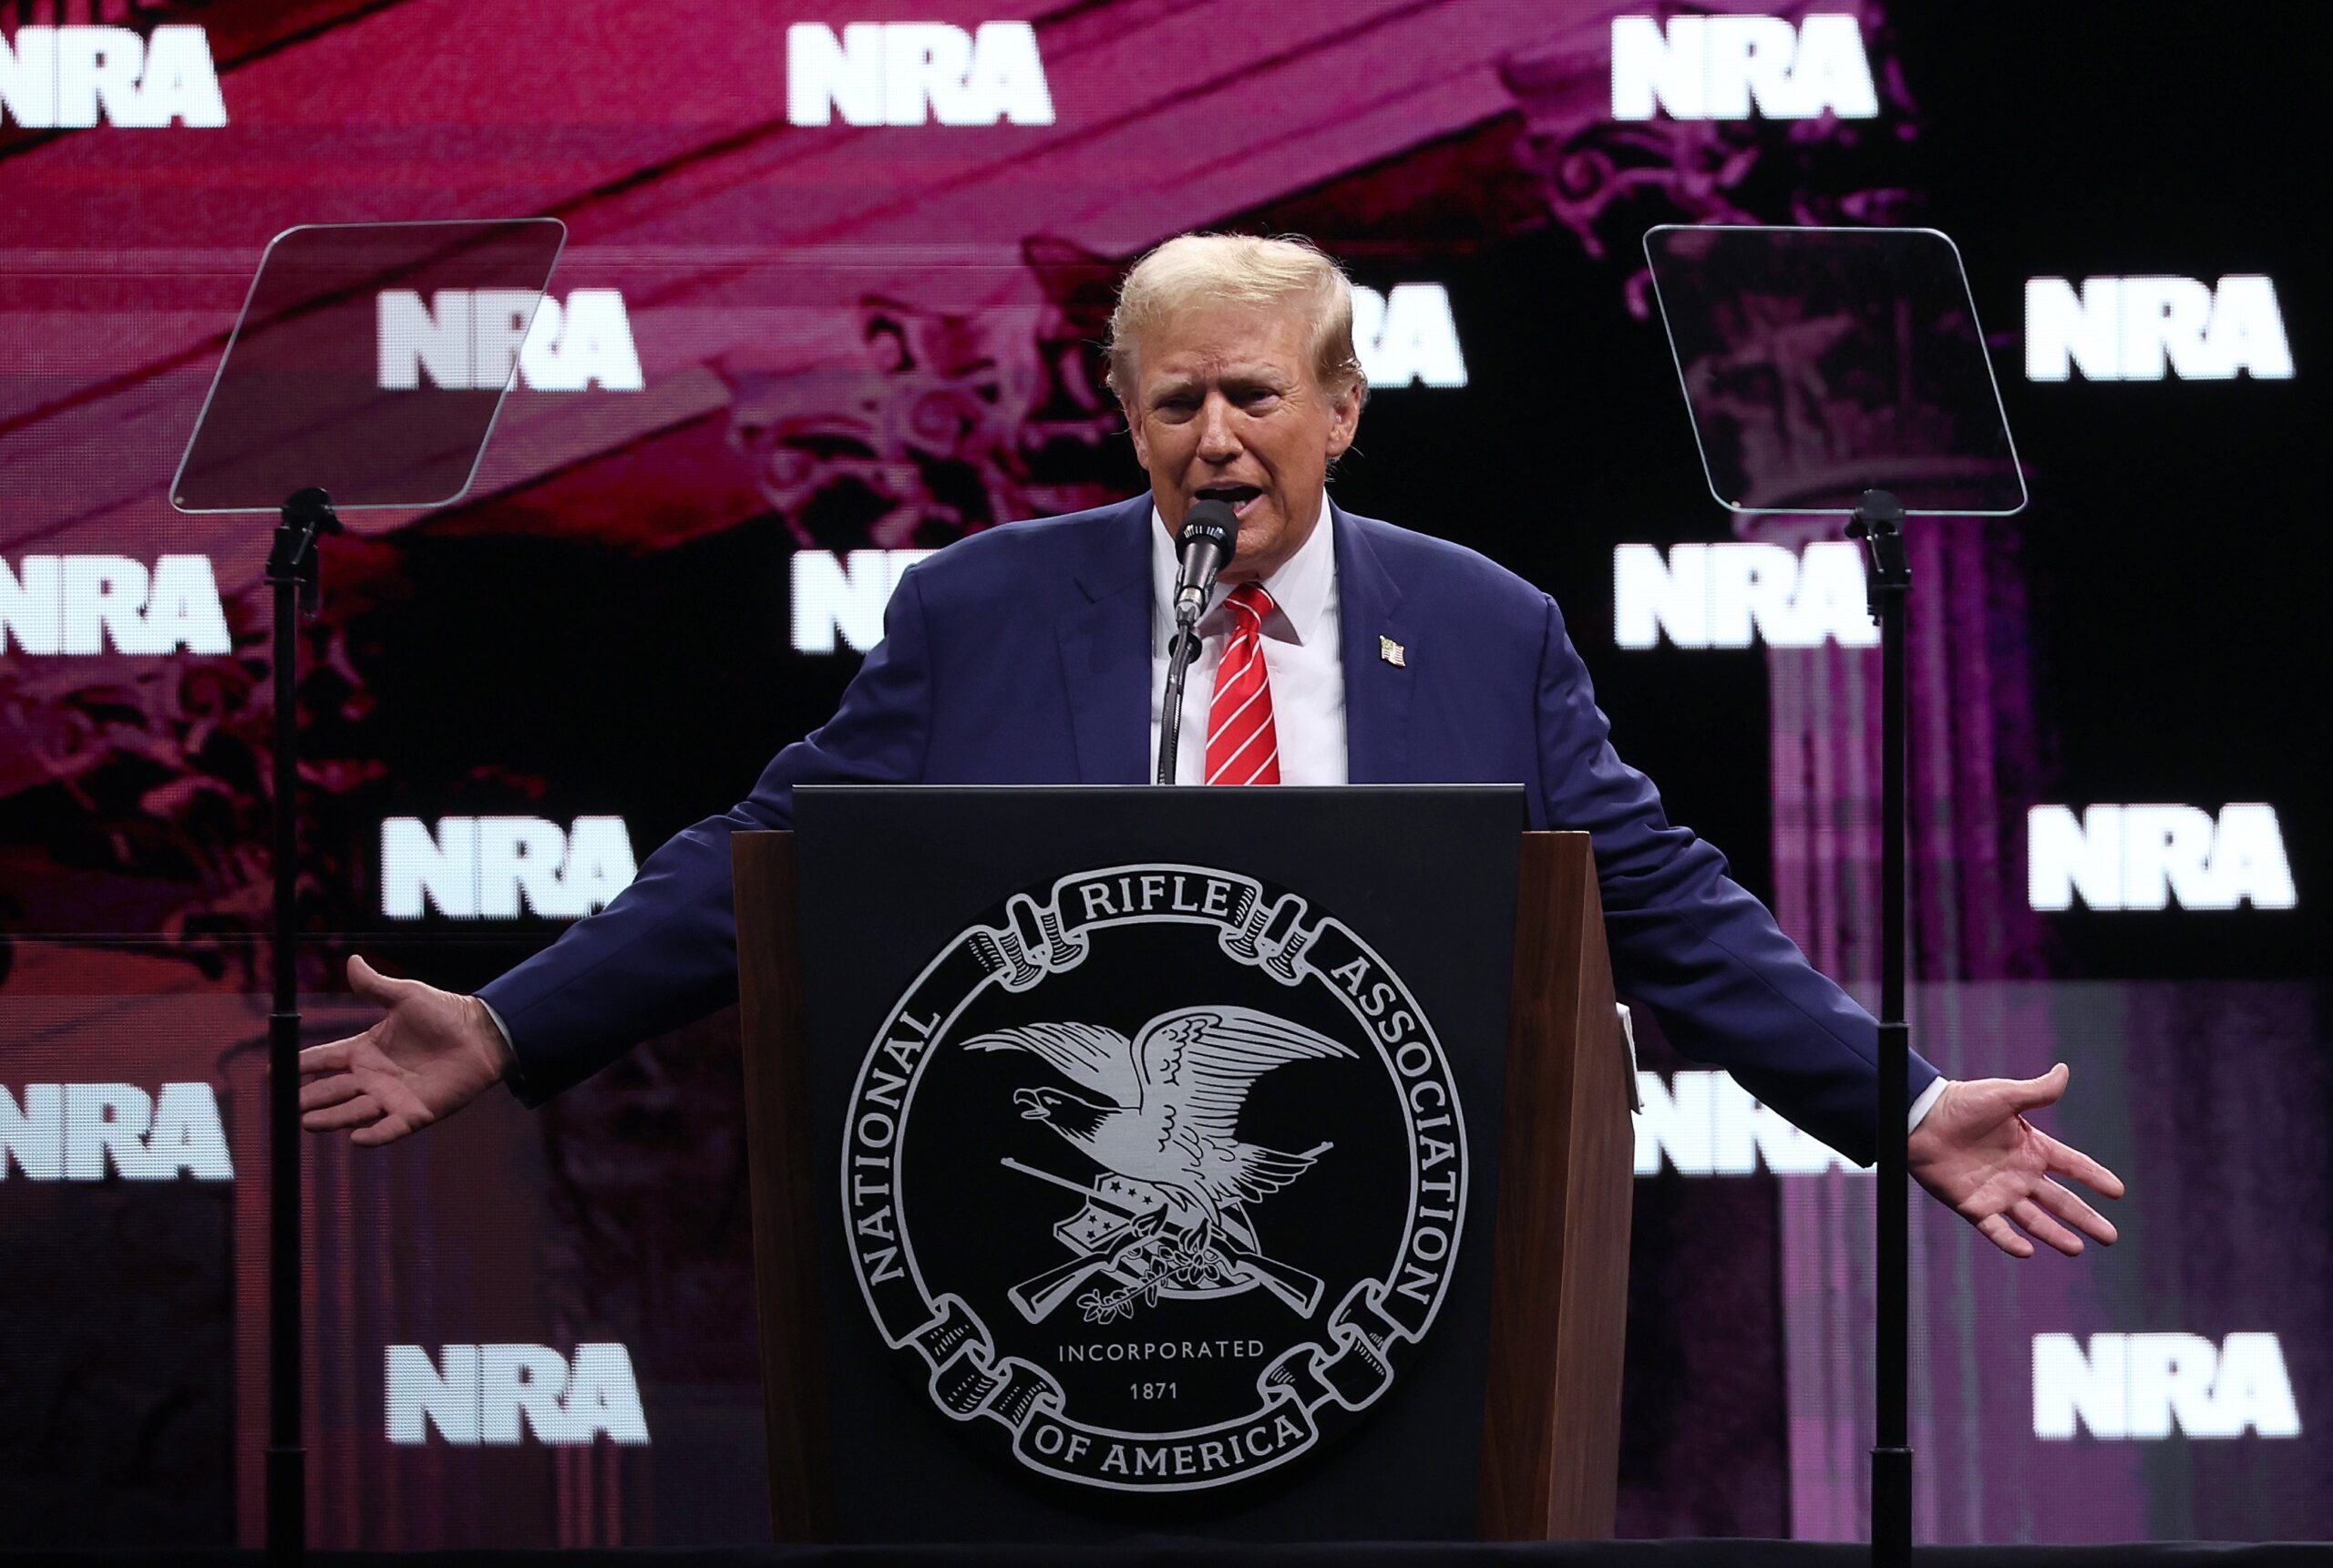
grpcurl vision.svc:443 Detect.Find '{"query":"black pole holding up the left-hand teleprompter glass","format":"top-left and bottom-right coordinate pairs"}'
top-left (266, 487), bottom-right (341, 1563)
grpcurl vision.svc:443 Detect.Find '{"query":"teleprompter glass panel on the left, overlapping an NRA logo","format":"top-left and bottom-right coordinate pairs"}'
top-left (170, 217), bottom-right (567, 511)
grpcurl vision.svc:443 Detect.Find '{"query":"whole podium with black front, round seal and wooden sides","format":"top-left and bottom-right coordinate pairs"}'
top-left (735, 786), bottom-right (1630, 1542)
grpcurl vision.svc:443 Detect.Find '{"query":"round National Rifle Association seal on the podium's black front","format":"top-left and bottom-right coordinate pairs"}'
top-left (842, 866), bottom-right (1467, 1493)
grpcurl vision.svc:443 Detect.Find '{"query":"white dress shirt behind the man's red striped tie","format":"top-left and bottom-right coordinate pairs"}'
top-left (1146, 495), bottom-right (1346, 784)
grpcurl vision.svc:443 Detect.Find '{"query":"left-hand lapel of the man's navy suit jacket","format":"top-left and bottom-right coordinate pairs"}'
top-left (1059, 492), bottom-right (1150, 784)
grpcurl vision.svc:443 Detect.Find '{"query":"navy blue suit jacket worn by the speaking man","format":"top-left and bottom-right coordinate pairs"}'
top-left (480, 495), bottom-right (1937, 1160)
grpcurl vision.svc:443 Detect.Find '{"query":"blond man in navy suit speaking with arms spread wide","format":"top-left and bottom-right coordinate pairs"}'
top-left (301, 236), bottom-right (2121, 1257)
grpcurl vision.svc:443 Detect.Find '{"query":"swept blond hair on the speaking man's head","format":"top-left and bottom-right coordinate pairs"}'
top-left (1105, 233), bottom-right (1370, 401)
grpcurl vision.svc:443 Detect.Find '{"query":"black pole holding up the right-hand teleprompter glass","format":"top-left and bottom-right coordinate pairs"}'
top-left (1848, 490), bottom-right (1911, 1568)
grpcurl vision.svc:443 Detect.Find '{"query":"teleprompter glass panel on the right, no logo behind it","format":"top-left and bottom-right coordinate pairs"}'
top-left (1645, 224), bottom-right (2025, 516)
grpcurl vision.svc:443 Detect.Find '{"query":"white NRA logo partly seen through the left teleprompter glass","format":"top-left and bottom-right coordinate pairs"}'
top-left (375, 290), bottom-right (644, 392)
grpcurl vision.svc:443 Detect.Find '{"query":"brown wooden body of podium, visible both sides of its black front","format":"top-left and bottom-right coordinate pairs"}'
top-left (733, 833), bottom-right (1633, 1542)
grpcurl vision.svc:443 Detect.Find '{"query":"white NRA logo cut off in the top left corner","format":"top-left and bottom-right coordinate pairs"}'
top-left (0, 24), bottom-right (226, 130)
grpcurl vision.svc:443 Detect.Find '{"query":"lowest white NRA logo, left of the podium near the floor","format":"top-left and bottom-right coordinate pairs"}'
top-left (387, 1344), bottom-right (649, 1447)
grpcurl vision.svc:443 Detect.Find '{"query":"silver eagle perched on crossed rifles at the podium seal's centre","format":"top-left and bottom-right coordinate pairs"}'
top-left (963, 1006), bottom-right (1353, 1323)
